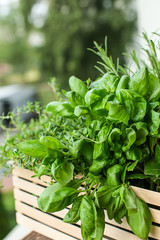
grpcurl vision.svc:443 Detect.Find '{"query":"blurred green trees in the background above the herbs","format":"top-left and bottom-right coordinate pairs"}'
top-left (0, 0), bottom-right (136, 88)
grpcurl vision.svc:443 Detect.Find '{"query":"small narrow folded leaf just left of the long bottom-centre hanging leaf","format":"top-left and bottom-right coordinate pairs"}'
top-left (63, 196), bottom-right (83, 223)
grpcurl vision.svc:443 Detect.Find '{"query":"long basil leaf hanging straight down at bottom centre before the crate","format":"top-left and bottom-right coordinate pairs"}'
top-left (80, 195), bottom-right (97, 238)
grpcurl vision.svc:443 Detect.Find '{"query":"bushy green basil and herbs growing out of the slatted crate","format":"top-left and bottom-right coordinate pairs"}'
top-left (0, 33), bottom-right (160, 240)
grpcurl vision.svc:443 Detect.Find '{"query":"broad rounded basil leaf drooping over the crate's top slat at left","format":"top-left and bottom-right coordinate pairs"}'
top-left (51, 160), bottom-right (74, 185)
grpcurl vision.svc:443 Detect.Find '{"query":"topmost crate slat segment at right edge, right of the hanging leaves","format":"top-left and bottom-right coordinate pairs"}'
top-left (132, 186), bottom-right (160, 207)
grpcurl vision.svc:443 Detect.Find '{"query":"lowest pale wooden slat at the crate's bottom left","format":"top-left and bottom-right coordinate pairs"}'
top-left (16, 213), bottom-right (77, 240)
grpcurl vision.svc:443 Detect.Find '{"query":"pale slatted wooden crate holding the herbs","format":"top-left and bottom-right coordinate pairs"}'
top-left (13, 167), bottom-right (160, 240)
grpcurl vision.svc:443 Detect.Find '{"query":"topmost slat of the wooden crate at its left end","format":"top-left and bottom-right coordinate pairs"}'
top-left (12, 167), bottom-right (51, 186)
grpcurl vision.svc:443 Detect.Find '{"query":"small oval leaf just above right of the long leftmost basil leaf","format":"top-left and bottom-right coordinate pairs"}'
top-left (39, 136), bottom-right (65, 150)
